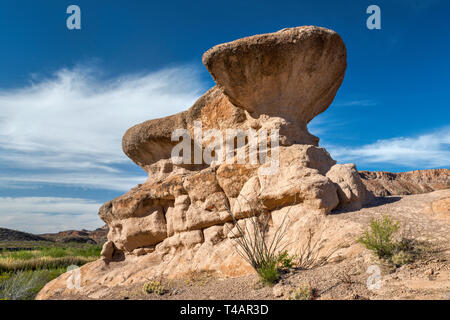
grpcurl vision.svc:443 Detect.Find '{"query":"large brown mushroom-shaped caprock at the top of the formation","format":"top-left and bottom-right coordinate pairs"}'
top-left (203, 26), bottom-right (347, 126)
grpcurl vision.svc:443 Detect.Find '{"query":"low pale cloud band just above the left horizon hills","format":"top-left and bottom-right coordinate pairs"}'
top-left (0, 197), bottom-right (104, 233)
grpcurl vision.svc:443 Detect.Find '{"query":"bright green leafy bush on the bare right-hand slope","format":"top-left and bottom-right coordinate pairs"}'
top-left (358, 216), bottom-right (399, 259)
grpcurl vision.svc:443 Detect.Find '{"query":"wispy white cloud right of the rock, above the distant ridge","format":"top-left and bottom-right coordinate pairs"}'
top-left (326, 127), bottom-right (450, 169)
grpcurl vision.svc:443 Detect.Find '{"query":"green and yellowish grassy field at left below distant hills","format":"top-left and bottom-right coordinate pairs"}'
top-left (0, 241), bottom-right (101, 300)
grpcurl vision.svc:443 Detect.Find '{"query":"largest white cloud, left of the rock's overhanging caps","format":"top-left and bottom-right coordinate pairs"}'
top-left (0, 67), bottom-right (203, 190)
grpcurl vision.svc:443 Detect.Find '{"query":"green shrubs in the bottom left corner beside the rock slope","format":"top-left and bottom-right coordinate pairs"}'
top-left (0, 269), bottom-right (66, 300)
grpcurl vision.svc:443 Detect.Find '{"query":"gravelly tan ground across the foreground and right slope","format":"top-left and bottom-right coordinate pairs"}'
top-left (37, 190), bottom-right (450, 300)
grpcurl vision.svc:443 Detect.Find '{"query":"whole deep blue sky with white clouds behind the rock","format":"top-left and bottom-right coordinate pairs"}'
top-left (0, 0), bottom-right (450, 233)
